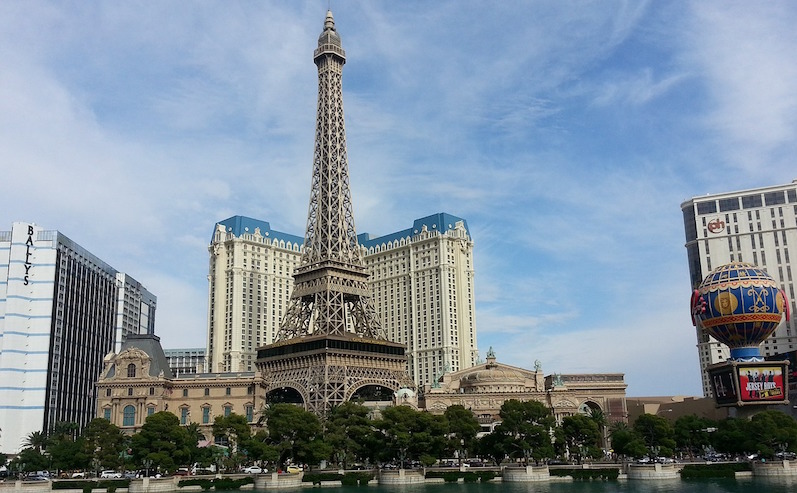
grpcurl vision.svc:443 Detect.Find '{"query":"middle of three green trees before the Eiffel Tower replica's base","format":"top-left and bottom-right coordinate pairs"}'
top-left (324, 401), bottom-right (374, 469)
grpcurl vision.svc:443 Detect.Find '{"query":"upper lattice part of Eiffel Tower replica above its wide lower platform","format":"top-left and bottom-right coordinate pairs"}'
top-left (277, 11), bottom-right (386, 341)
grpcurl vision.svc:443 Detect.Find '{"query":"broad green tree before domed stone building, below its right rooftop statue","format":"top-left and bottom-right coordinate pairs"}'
top-left (494, 399), bottom-right (556, 465)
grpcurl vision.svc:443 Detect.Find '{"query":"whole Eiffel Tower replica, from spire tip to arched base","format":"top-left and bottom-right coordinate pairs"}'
top-left (257, 11), bottom-right (415, 416)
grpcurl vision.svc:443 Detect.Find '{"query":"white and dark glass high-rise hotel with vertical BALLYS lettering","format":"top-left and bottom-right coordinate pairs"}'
top-left (0, 222), bottom-right (157, 453)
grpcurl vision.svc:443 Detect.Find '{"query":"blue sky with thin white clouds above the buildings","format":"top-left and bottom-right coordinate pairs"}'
top-left (0, 0), bottom-right (797, 396)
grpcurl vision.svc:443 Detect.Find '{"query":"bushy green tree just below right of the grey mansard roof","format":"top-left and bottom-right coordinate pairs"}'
top-left (130, 411), bottom-right (192, 472)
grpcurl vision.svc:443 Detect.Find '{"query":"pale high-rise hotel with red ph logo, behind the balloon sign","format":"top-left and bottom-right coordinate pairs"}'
top-left (681, 180), bottom-right (797, 396)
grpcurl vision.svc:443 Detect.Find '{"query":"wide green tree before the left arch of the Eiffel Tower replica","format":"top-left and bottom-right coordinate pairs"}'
top-left (265, 404), bottom-right (331, 467)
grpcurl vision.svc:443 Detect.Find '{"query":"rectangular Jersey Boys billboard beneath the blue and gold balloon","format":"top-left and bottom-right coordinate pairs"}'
top-left (708, 361), bottom-right (789, 406)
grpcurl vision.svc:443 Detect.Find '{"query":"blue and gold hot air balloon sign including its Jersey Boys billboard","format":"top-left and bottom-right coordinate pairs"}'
top-left (691, 262), bottom-right (789, 406)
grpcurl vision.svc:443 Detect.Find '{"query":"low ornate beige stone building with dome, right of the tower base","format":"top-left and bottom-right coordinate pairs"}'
top-left (420, 348), bottom-right (628, 431)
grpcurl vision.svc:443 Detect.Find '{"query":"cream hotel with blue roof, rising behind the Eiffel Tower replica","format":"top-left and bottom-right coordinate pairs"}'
top-left (206, 213), bottom-right (478, 386)
